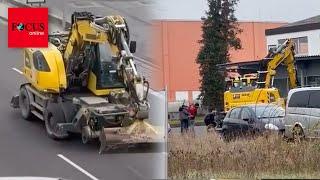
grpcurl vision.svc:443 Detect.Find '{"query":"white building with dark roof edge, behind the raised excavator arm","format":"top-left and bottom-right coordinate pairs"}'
top-left (265, 15), bottom-right (320, 96)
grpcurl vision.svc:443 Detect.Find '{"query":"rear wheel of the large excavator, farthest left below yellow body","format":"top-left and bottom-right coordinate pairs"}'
top-left (19, 87), bottom-right (32, 121)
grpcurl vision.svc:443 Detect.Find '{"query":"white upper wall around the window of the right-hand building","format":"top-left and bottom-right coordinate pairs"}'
top-left (266, 29), bottom-right (320, 56)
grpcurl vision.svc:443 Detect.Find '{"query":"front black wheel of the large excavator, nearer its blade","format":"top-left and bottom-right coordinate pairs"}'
top-left (44, 102), bottom-right (69, 140)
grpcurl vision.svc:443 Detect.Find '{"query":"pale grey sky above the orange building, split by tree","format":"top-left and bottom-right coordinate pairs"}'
top-left (154, 0), bottom-right (320, 22)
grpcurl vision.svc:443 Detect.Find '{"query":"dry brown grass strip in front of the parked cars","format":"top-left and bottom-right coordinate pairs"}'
top-left (168, 133), bottom-right (320, 179)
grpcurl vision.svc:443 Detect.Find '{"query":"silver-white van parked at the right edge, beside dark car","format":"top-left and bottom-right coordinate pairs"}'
top-left (284, 87), bottom-right (320, 139)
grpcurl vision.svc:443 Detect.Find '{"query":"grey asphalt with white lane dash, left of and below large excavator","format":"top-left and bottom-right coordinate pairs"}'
top-left (0, 0), bottom-right (166, 180)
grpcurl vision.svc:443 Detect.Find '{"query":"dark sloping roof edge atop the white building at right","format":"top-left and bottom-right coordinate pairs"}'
top-left (265, 15), bottom-right (320, 36)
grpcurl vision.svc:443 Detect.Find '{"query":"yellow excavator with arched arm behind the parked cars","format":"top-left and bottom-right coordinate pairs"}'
top-left (224, 39), bottom-right (298, 112)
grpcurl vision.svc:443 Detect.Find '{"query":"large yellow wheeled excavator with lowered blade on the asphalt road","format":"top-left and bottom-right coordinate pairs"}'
top-left (11, 12), bottom-right (160, 153)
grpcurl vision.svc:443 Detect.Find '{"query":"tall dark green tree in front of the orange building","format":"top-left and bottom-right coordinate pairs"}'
top-left (196, 0), bottom-right (241, 111)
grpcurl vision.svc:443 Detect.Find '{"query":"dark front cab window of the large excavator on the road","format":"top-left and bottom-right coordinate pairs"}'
top-left (93, 43), bottom-right (124, 89)
